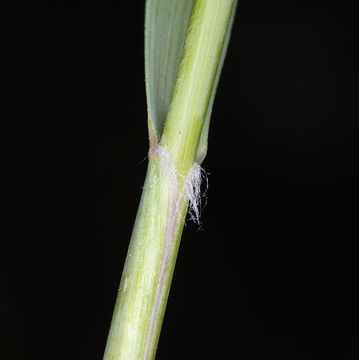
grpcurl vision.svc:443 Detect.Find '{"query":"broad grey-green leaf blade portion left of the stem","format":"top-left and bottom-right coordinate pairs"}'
top-left (145, 0), bottom-right (194, 140)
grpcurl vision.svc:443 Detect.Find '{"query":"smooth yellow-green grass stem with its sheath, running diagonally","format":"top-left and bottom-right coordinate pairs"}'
top-left (104, 0), bottom-right (234, 360)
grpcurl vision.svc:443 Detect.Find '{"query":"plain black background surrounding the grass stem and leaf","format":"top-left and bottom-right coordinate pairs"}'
top-left (0, 0), bottom-right (359, 360)
